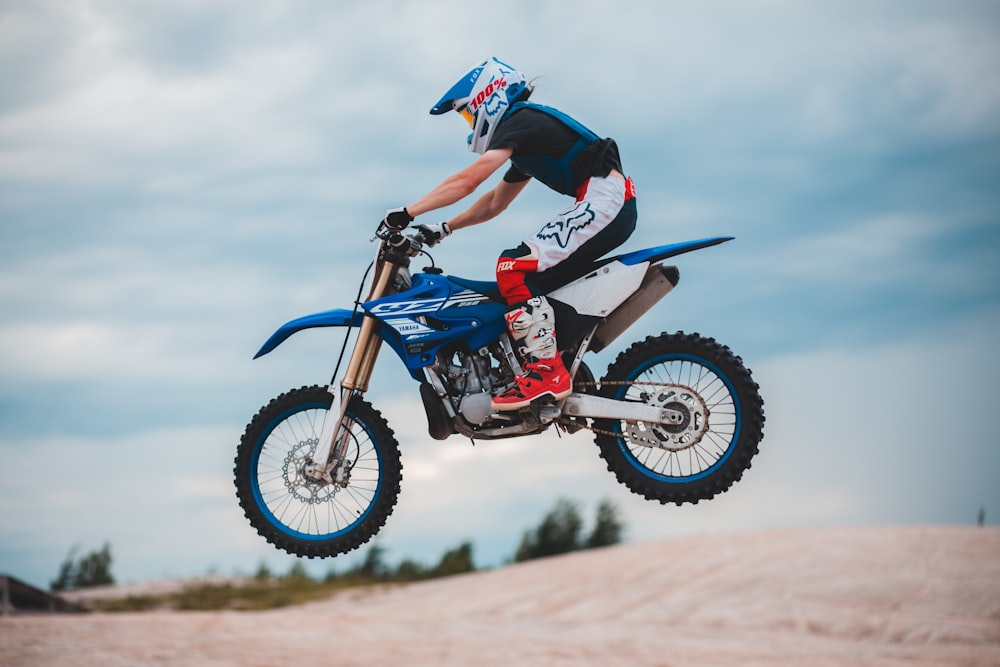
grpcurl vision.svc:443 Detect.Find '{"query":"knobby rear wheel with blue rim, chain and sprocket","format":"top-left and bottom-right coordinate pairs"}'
top-left (595, 332), bottom-right (764, 505)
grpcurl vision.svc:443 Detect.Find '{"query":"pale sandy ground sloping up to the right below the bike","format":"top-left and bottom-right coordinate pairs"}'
top-left (0, 527), bottom-right (1000, 667)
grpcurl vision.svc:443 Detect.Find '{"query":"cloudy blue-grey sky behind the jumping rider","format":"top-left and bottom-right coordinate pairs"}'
top-left (0, 0), bottom-right (1000, 587)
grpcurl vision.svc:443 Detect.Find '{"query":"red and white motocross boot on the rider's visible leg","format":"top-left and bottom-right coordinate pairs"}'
top-left (491, 297), bottom-right (573, 411)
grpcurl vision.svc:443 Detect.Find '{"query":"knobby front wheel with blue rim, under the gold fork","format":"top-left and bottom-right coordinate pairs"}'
top-left (233, 386), bottom-right (403, 558)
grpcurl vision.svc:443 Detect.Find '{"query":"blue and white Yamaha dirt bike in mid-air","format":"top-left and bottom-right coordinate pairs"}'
top-left (234, 224), bottom-right (764, 557)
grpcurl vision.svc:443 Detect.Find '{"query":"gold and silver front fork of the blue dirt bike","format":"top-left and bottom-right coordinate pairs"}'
top-left (304, 245), bottom-right (406, 485)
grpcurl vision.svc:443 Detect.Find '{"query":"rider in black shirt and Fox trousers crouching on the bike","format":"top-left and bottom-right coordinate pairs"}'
top-left (382, 57), bottom-right (636, 410)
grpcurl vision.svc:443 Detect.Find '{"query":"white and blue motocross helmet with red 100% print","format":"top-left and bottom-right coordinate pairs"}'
top-left (431, 57), bottom-right (530, 155)
